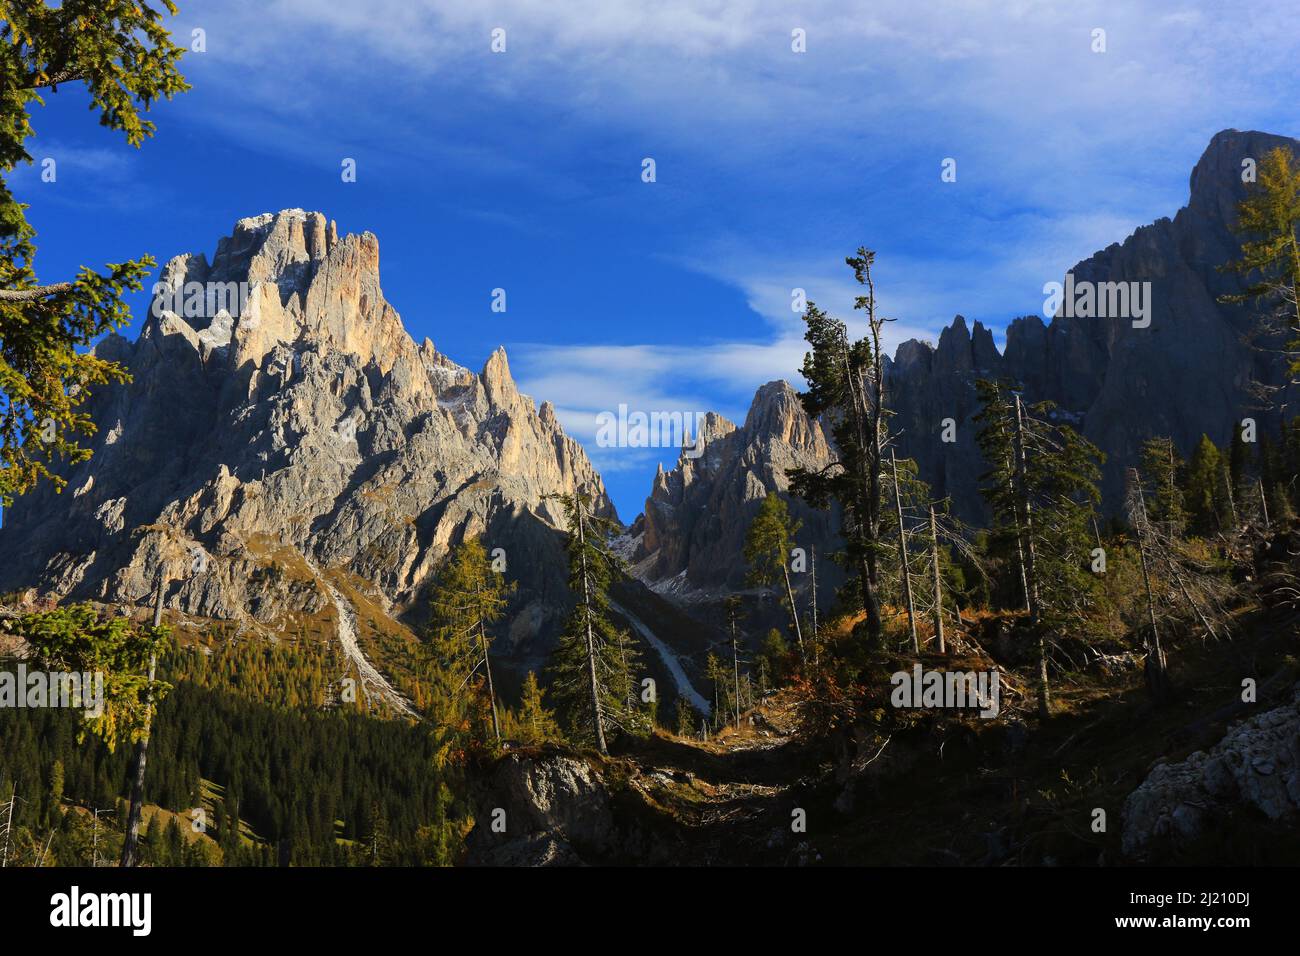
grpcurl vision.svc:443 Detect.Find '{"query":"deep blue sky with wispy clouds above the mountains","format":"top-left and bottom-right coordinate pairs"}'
top-left (13, 0), bottom-right (1300, 520)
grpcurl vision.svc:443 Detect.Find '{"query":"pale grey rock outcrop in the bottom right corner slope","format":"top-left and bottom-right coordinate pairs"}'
top-left (1123, 687), bottom-right (1300, 857)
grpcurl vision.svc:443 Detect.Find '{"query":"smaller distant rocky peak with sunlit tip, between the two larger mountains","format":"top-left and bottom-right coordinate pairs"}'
top-left (632, 381), bottom-right (835, 593)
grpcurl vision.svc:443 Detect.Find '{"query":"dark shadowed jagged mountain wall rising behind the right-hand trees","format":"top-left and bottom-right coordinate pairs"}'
top-left (888, 130), bottom-right (1300, 520)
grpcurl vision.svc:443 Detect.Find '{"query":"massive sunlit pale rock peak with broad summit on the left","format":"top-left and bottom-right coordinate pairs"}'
top-left (0, 209), bottom-right (614, 653)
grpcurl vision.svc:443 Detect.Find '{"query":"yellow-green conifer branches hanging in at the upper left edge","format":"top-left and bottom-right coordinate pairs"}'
top-left (0, 0), bottom-right (189, 507)
